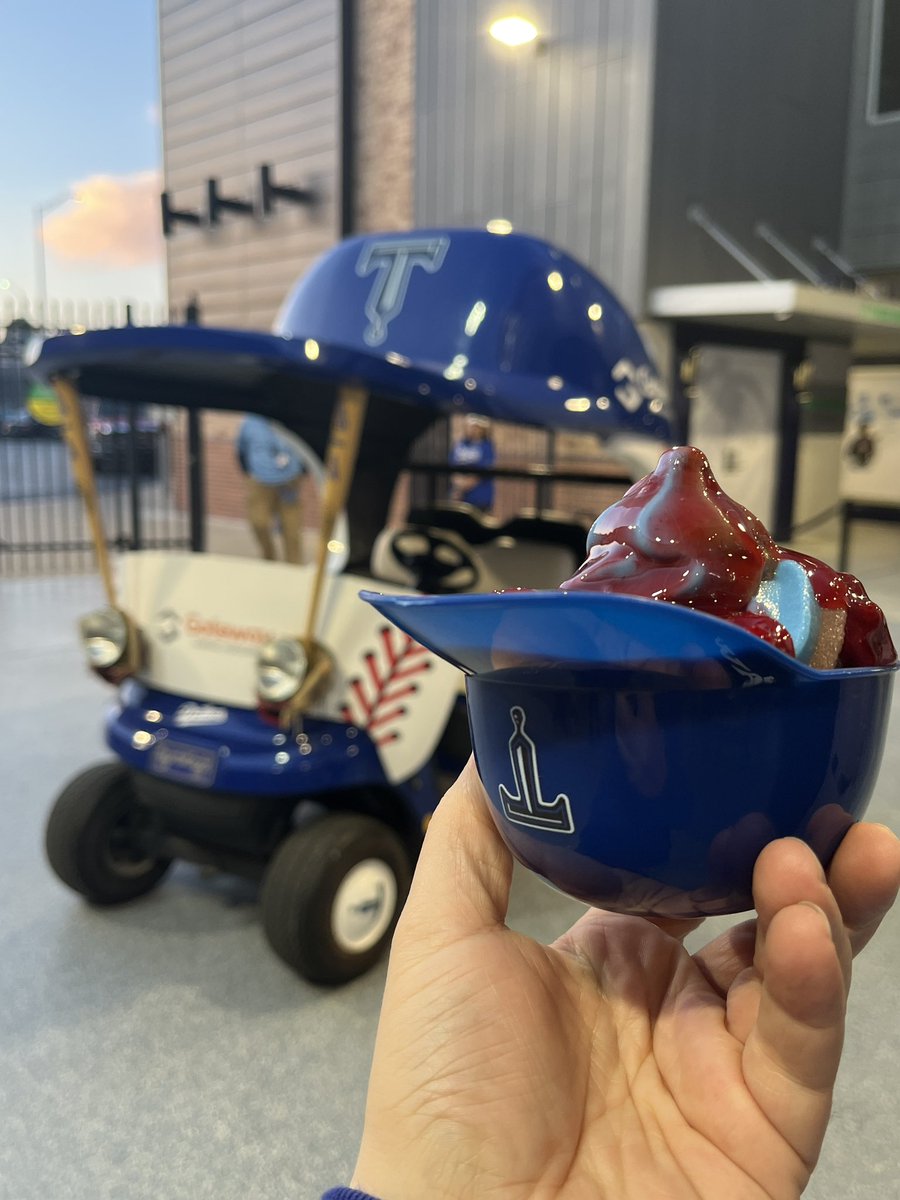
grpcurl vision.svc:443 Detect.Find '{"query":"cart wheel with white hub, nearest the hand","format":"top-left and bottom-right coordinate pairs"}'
top-left (262, 812), bottom-right (412, 984)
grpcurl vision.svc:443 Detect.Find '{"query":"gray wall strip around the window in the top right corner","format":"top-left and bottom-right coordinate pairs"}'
top-left (841, 0), bottom-right (900, 271)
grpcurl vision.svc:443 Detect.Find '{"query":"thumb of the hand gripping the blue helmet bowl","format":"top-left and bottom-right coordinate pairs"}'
top-left (394, 758), bottom-right (512, 950)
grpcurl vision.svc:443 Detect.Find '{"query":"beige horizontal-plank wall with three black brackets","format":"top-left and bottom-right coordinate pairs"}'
top-left (160, 0), bottom-right (340, 328)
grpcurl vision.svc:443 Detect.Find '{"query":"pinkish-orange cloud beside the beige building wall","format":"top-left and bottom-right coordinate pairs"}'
top-left (43, 170), bottom-right (162, 266)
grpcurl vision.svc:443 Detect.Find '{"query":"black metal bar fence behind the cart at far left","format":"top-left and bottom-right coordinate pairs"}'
top-left (0, 298), bottom-right (191, 576)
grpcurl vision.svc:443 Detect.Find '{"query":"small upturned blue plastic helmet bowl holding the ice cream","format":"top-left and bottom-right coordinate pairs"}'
top-left (365, 592), bottom-right (895, 917)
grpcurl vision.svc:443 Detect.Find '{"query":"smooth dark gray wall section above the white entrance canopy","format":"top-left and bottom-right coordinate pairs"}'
top-left (648, 0), bottom-right (856, 287)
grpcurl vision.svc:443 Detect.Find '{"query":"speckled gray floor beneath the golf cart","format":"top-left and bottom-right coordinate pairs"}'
top-left (0, 526), bottom-right (900, 1200)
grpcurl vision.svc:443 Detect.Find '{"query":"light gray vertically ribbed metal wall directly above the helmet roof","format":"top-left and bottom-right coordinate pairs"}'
top-left (415, 0), bottom-right (656, 310)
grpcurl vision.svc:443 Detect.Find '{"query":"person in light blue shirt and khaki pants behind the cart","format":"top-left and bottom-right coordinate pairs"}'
top-left (238, 413), bottom-right (304, 563)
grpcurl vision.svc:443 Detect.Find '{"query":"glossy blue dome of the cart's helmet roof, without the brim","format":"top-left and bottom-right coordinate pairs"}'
top-left (275, 229), bottom-right (670, 439)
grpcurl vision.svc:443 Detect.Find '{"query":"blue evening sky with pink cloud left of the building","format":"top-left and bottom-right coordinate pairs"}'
top-left (0, 0), bottom-right (166, 314)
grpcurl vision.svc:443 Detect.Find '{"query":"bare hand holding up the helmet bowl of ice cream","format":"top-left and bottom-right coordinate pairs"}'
top-left (353, 763), bottom-right (900, 1200)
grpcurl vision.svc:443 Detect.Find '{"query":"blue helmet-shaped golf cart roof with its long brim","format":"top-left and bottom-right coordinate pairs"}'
top-left (34, 229), bottom-right (670, 564)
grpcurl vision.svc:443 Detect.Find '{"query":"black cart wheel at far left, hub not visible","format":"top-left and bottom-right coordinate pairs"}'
top-left (44, 762), bottom-right (172, 904)
